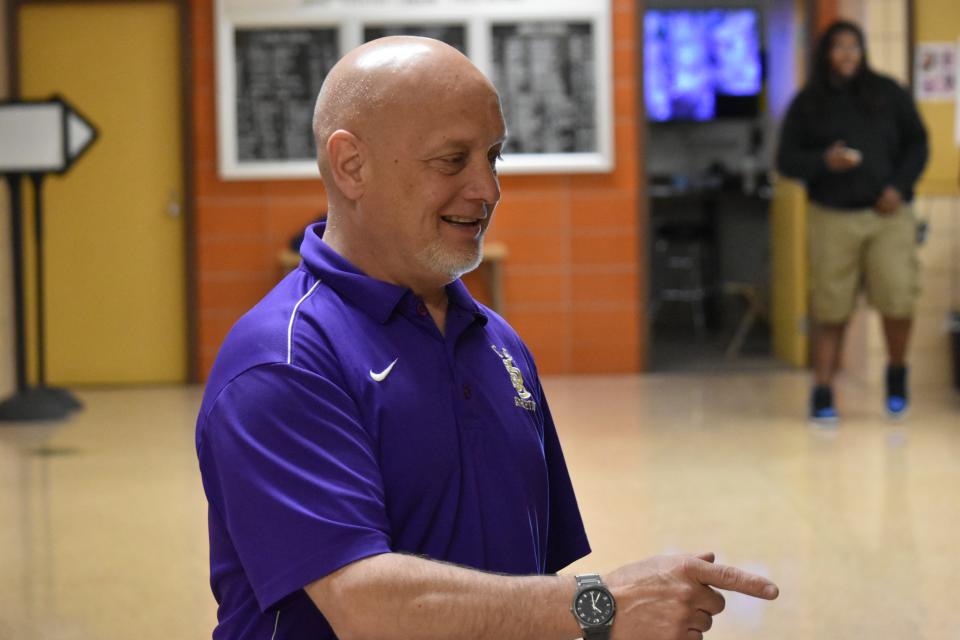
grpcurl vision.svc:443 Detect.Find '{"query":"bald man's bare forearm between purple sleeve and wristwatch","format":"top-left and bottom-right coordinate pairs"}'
top-left (306, 553), bottom-right (580, 640)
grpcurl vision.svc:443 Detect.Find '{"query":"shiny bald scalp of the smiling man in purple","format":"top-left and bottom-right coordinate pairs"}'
top-left (313, 36), bottom-right (496, 189)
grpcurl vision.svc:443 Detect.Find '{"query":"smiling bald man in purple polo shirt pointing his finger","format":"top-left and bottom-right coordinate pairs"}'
top-left (197, 37), bottom-right (777, 640)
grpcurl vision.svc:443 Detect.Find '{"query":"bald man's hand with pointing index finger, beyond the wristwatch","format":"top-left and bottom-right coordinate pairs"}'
top-left (606, 553), bottom-right (780, 640)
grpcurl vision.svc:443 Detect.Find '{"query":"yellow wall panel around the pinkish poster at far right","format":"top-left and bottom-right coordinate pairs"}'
top-left (914, 0), bottom-right (960, 195)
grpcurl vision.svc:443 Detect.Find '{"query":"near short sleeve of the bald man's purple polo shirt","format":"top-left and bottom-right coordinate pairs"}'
top-left (199, 364), bottom-right (390, 611)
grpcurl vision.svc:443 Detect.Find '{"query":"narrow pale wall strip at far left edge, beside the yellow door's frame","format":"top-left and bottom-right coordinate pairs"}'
top-left (0, 0), bottom-right (15, 399)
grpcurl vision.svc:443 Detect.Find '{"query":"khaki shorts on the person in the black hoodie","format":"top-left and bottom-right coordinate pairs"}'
top-left (807, 202), bottom-right (920, 323)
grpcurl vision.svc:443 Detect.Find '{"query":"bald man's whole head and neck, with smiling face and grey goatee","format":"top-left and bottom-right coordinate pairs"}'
top-left (313, 37), bottom-right (506, 292)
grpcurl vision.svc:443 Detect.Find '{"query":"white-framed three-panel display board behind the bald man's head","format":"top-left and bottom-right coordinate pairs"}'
top-left (216, 0), bottom-right (613, 179)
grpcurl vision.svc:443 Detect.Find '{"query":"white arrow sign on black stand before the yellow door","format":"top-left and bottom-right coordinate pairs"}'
top-left (0, 97), bottom-right (97, 421)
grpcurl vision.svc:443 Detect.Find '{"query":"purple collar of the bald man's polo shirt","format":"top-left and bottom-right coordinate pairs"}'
top-left (300, 222), bottom-right (487, 324)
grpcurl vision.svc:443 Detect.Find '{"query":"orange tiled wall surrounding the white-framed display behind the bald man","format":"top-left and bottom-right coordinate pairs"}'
top-left (190, 0), bottom-right (646, 378)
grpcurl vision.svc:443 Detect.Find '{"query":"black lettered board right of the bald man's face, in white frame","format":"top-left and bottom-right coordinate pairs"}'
top-left (492, 22), bottom-right (597, 154)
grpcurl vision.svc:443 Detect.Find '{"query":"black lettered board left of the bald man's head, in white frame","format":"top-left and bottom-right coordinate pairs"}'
top-left (234, 28), bottom-right (340, 161)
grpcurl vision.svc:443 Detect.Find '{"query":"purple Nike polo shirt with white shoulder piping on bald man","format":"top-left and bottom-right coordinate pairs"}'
top-left (197, 223), bottom-right (590, 640)
